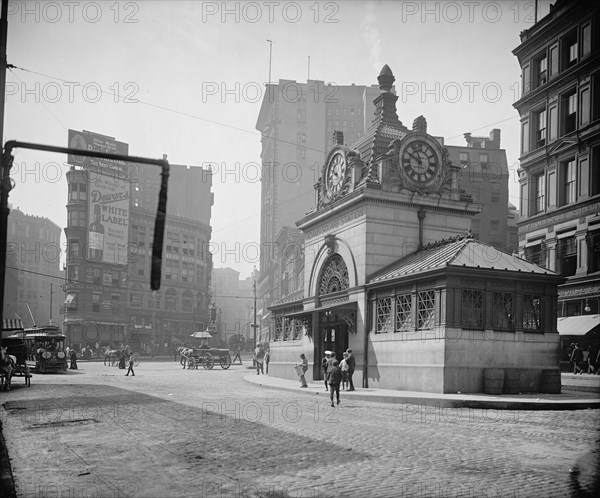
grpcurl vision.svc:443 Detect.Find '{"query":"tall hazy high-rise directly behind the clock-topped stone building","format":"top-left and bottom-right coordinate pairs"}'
top-left (256, 80), bottom-right (379, 340)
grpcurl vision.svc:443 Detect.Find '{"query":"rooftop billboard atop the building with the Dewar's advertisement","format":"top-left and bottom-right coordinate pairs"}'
top-left (67, 130), bottom-right (136, 180)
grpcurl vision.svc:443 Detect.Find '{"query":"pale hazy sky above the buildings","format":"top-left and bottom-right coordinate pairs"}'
top-left (4, 0), bottom-right (549, 279)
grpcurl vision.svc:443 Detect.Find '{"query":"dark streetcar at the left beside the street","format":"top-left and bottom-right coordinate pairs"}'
top-left (23, 325), bottom-right (67, 373)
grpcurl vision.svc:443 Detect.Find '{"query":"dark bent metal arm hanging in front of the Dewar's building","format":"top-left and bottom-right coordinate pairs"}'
top-left (0, 140), bottom-right (169, 329)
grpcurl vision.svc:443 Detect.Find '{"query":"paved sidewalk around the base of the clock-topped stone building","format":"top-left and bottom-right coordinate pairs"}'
top-left (244, 374), bottom-right (600, 410)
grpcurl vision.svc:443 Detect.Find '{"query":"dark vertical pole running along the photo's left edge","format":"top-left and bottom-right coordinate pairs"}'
top-left (0, 0), bottom-right (12, 334)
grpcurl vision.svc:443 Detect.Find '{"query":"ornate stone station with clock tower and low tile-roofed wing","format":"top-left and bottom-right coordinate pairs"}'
top-left (269, 66), bottom-right (561, 392)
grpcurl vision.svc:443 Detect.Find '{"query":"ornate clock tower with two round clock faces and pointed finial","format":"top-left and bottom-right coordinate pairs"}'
top-left (297, 65), bottom-right (480, 292)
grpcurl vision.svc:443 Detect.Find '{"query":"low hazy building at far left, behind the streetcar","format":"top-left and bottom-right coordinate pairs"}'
top-left (4, 208), bottom-right (63, 327)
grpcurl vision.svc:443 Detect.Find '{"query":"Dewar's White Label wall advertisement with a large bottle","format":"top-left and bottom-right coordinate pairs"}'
top-left (87, 171), bottom-right (130, 265)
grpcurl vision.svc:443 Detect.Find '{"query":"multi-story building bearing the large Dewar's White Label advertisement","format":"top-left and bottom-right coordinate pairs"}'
top-left (64, 131), bottom-right (213, 352)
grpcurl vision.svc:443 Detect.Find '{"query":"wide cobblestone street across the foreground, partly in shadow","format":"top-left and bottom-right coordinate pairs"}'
top-left (1, 362), bottom-right (600, 497)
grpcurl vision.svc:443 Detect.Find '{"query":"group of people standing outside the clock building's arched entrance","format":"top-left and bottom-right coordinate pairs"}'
top-left (296, 349), bottom-right (356, 406)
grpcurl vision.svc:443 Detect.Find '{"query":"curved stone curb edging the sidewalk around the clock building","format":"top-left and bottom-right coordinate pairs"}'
top-left (243, 376), bottom-right (600, 411)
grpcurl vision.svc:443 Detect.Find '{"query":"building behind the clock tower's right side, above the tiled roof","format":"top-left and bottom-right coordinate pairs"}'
top-left (446, 129), bottom-right (514, 251)
